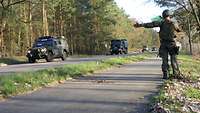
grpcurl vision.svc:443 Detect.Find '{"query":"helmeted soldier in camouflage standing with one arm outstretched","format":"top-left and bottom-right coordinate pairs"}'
top-left (134, 10), bottom-right (181, 79)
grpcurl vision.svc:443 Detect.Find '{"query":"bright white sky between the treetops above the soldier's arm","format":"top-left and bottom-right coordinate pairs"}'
top-left (115, 0), bottom-right (164, 22)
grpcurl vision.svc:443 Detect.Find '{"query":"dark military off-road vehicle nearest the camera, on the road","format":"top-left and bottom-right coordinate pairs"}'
top-left (26, 36), bottom-right (69, 63)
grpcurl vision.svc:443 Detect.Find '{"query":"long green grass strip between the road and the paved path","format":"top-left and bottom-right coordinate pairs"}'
top-left (0, 55), bottom-right (147, 98)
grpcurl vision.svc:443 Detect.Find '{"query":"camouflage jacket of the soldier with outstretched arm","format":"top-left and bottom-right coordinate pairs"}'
top-left (141, 20), bottom-right (181, 44)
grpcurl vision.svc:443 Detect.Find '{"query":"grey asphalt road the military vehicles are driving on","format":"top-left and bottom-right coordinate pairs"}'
top-left (0, 53), bottom-right (136, 75)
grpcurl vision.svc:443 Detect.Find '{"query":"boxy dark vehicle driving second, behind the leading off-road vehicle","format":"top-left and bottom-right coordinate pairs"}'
top-left (110, 39), bottom-right (128, 55)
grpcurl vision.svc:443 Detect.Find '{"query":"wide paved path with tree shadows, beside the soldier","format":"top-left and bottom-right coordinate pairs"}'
top-left (0, 58), bottom-right (162, 113)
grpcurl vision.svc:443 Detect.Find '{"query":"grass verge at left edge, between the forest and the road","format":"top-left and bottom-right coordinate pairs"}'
top-left (0, 56), bottom-right (27, 65)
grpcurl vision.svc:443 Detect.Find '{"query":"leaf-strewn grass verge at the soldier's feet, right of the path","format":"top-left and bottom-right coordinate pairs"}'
top-left (151, 55), bottom-right (200, 113)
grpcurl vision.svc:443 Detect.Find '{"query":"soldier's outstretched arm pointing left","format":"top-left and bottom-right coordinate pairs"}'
top-left (134, 21), bottom-right (161, 28)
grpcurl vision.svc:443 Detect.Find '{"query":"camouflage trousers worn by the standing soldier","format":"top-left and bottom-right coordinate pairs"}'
top-left (159, 42), bottom-right (180, 78)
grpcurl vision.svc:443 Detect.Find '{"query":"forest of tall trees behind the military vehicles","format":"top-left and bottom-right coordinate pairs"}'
top-left (0, 0), bottom-right (159, 57)
